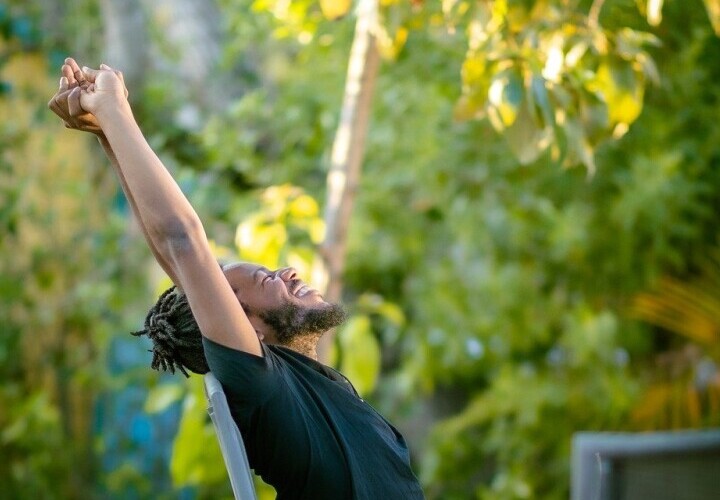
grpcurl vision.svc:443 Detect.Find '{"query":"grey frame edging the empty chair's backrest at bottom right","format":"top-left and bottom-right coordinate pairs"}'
top-left (571, 429), bottom-right (720, 500)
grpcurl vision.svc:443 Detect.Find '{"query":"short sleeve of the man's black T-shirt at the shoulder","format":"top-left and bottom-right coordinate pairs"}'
top-left (202, 337), bottom-right (283, 406)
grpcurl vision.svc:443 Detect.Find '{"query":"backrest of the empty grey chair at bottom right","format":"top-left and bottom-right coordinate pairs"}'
top-left (571, 429), bottom-right (720, 500)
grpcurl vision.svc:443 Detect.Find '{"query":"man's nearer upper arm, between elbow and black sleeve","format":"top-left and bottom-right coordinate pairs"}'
top-left (168, 228), bottom-right (263, 356)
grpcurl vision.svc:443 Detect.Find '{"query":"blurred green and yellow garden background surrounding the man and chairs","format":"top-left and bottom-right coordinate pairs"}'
top-left (0, 0), bottom-right (720, 499)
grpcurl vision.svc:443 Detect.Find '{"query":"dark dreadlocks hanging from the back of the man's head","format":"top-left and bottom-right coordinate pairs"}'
top-left (132, 286), bottom-right (210, 377)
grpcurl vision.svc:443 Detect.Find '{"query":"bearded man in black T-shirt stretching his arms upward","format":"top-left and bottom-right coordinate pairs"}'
top-left (49, 59), bottom-right (423, 500)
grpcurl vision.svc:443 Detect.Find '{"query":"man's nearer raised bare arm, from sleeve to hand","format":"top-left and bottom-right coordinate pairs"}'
top-left (56, 60), bottom-right (262, 356)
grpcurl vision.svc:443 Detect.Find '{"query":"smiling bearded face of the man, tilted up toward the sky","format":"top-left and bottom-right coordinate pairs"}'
top-left (223, 263), bottom-right (345, 344)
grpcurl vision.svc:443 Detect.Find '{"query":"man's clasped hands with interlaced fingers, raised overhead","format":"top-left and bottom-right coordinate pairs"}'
top-left (48, 57), bottom-right (128, 137)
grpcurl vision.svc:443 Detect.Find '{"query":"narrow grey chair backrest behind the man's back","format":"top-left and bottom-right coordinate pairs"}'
top-left (204, 372), bottom-right (257, 500)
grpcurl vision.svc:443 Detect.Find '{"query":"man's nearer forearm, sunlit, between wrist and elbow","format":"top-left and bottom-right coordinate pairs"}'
top-left (96, 105), bottom-right (204, 269)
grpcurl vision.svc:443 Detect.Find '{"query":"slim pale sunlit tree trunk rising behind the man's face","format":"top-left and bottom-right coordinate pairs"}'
top-left (318, 0), bottom-right (380, 362)
